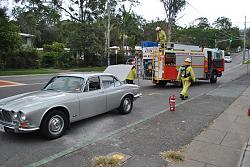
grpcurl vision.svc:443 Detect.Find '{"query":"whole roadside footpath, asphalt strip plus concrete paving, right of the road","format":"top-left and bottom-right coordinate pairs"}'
top-left (41, 75), bottom-right (250, 167)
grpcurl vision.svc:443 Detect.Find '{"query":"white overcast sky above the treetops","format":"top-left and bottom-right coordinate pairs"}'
top-left (135, 0), bottom-right (250, 29)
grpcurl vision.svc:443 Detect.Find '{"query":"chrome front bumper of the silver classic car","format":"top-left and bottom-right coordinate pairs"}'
top-left (0, 121), bottom-right (39, 133)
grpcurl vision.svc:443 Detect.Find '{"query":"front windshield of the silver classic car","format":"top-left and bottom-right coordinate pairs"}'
top-left (43, 76), bottom-right (84, 92)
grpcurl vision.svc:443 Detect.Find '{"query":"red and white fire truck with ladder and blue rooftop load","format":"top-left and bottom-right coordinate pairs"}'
top-left (142, 41), bottom-right (224, 85)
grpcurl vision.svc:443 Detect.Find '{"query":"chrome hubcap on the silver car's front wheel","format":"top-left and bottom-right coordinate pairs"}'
top-left (48, 115), bottom-right (64, 135)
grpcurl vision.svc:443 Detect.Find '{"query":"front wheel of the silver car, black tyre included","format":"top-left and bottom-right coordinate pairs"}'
top-left (41, 110), bottom-right (68, 139)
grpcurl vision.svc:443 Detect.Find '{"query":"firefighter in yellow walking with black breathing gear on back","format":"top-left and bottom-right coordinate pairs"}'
top-left (177, 58), bottom-right (195, 100)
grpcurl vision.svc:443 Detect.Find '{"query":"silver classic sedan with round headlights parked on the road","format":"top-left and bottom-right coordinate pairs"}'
top-left (0, 73), bottom-right (141, 139)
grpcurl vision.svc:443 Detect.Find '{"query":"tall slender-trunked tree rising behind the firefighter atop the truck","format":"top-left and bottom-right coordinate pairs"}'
top-left (160, 0), bottom-right (187, 42)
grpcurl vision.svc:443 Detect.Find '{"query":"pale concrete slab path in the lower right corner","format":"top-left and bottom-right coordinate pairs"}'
top-left (170, 86), bottom-right (250, 167)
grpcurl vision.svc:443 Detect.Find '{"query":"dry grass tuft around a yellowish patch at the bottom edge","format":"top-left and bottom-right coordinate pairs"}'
top-left (93, 156), bottom-right (120, 167)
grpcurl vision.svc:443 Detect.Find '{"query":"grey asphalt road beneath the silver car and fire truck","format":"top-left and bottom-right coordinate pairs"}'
top-left (0, 54), bottom-right (246, 167)
